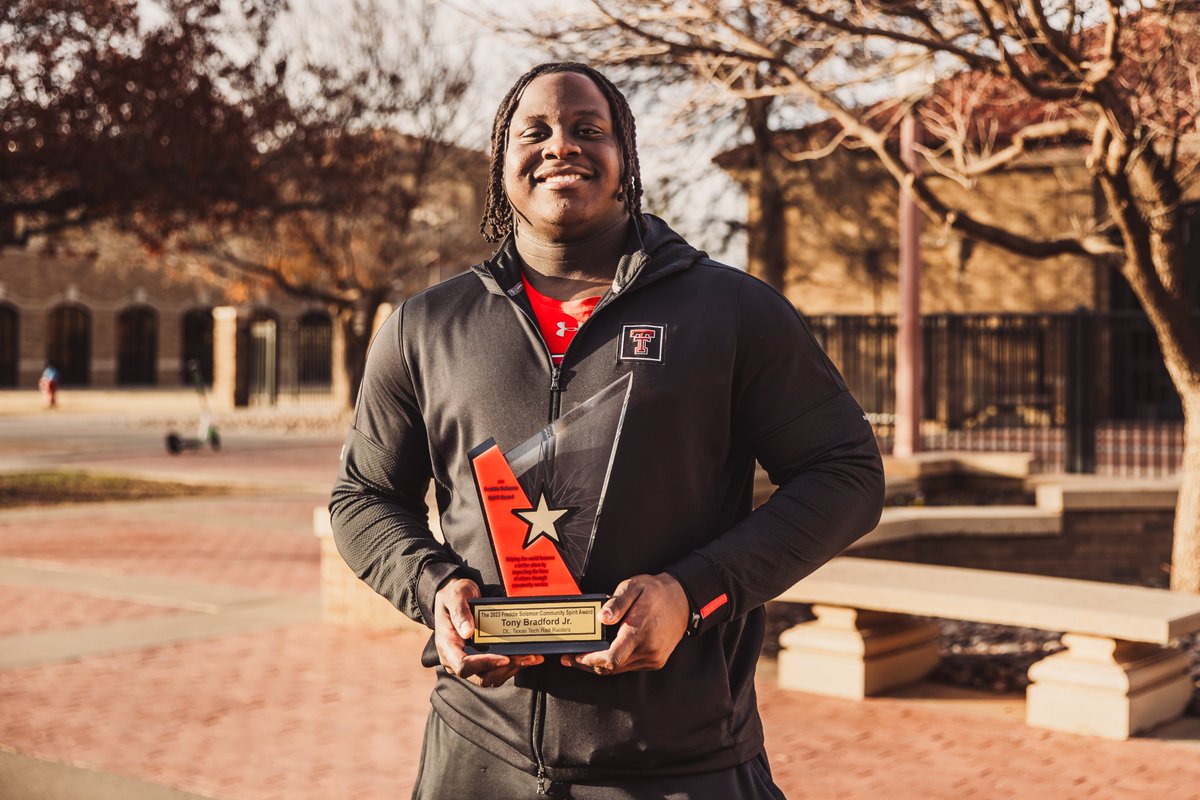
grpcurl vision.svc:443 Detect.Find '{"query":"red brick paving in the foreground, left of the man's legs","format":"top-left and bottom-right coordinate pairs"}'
top-left (0, 625), bottom-right (431, 800)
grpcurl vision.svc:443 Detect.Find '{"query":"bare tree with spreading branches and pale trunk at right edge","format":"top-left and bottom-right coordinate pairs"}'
top-left (516, 0), bottom-right (1200, 591)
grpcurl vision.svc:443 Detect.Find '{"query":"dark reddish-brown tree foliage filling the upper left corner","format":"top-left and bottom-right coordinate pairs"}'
top-left (0, 0), bottom-right (300, 242)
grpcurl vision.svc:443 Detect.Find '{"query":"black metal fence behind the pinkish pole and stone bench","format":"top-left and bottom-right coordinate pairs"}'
top-left (809, 312), bottom-right (1183, 475)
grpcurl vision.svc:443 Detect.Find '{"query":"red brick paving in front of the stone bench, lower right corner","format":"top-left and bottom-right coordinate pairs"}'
top-left (758, 680), bottom-right (1200, 800)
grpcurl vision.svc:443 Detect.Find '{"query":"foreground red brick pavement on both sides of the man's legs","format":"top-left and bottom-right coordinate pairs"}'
top-left (7, 625), bottom-right (1200, 800)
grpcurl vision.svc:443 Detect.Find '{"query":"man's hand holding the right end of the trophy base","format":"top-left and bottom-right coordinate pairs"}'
top-left (563, 572), bottom-right (688, 675)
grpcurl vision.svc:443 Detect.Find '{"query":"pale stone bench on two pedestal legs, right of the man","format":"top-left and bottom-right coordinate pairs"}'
top-left (778, 557), bottom-right (1200, 739)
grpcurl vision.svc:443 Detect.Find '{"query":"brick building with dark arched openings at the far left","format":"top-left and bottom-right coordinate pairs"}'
top-left (0, 247), bottom-right (332, 387)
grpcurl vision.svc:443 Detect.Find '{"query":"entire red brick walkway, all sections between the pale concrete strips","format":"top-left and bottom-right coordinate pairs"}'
top-left (0, 419), bottom-right (1200, 800)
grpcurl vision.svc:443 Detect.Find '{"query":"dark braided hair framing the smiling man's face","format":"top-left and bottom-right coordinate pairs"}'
top-left (479, 61), bottom-right (642, 242)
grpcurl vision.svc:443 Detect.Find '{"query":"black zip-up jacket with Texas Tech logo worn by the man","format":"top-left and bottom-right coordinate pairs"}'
top-left (330, 217), bottom-right (883, 782)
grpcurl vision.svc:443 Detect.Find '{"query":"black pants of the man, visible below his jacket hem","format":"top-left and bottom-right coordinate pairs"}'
top-left (413, 711), bottom-right (785, 800)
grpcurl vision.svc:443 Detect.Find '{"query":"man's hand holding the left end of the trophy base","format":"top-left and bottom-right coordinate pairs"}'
top-left (433, 578), bottom-right (542, 686)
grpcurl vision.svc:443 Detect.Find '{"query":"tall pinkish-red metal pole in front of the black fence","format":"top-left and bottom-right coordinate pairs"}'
top-left (893, 112), bottom-right (924, 457)
